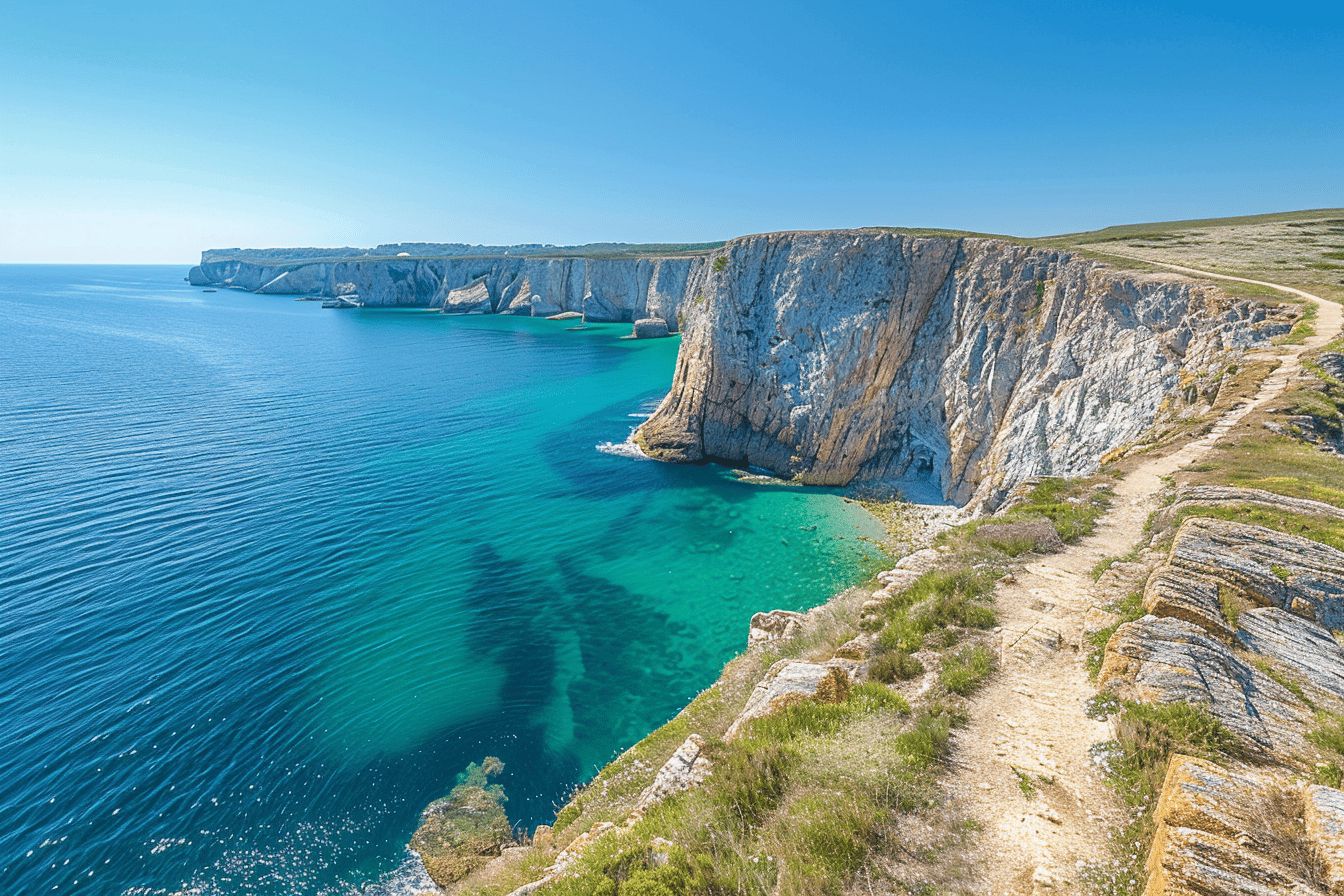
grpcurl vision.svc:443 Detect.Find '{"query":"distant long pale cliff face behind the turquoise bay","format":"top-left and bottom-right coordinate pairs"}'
top-left (188, 250), bottom-right (706, 329)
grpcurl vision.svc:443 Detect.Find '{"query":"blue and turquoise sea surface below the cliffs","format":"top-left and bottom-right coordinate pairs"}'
top-left (0, 266), bottom-right (879, 896)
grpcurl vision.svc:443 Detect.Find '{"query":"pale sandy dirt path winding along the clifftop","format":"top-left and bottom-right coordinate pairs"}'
top-left (949, 259), bottom-right (1344, 896)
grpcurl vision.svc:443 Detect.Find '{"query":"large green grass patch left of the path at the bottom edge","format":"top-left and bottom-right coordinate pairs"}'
top-left (540, 684), bottom-right (964, 896)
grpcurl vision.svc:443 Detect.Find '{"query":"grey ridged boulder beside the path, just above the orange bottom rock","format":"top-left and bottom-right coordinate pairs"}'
top-left (1098, 615), bottom-right (1312, 759)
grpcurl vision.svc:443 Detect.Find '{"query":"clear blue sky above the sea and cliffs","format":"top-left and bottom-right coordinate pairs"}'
top-left (0, 0), bottom-right (1344, 262)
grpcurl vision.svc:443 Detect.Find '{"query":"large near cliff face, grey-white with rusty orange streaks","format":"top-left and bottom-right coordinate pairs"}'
top-left (636, 230), bottom-right (1265, 504)
